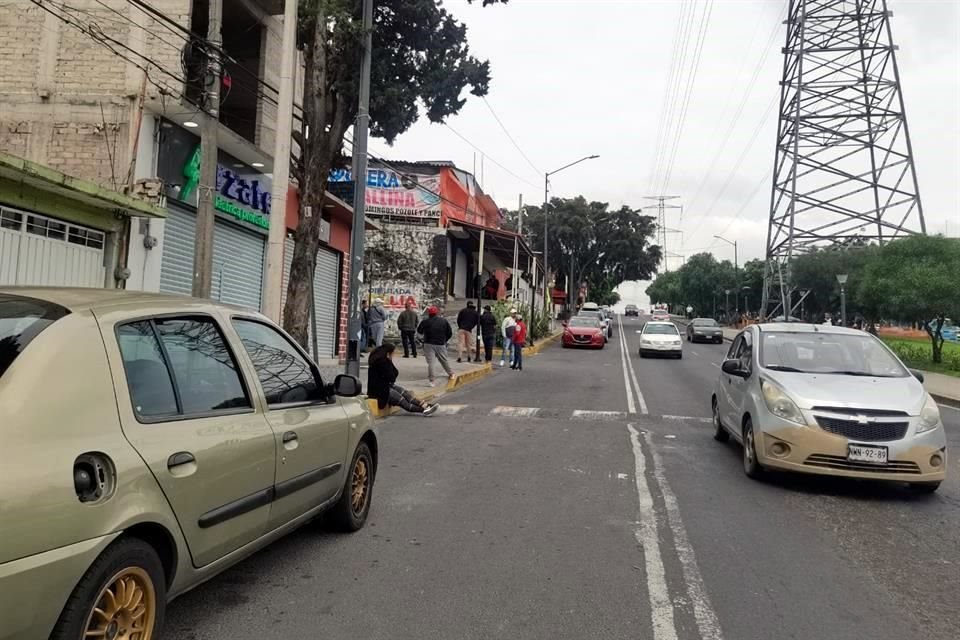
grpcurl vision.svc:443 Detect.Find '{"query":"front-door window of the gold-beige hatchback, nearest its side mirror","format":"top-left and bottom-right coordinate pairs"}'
top-left (233, 319), bottom-right (323, 405)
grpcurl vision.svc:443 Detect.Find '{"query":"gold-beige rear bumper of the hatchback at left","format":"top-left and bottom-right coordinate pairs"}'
top-left (0, 533), bottom-right (120, 640)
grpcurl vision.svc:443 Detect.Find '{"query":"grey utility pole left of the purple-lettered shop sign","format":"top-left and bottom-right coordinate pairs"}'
top-left (192, 0), bottom-right (223, 298)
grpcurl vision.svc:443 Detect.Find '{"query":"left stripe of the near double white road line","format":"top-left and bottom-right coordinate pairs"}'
top-left (627, 424), bottom-right (677, 640)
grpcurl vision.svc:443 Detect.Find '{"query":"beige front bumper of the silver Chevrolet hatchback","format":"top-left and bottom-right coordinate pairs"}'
top-left (756, 427), bottom-right (948, 482)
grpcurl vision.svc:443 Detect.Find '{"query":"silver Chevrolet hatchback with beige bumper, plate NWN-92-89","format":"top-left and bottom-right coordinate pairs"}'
top-left (711, 323), bottom-right (947, 492)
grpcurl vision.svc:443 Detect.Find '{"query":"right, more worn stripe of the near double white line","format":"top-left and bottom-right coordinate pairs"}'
top-left (630, 428), bottom-right (723, 640)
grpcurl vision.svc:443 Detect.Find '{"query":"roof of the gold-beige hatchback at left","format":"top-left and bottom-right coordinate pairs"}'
top-left (0, 287), bottom-right (256, 313)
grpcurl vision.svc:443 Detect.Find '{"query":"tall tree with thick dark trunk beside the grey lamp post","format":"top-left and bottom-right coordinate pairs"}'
top-left (283, 0), bottom-right (506, 344)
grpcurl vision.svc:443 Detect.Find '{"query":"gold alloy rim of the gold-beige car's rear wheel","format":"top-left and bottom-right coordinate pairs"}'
top-left (83, 567), bottom-right (157, 640)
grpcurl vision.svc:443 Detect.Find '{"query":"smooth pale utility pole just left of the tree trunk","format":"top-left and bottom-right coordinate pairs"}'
top-left (263, 0), bottom-right (296, 322)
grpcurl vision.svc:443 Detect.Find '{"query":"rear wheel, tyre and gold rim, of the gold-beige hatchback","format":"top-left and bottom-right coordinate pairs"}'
top-left (50, 538), bottom-right (167, 640)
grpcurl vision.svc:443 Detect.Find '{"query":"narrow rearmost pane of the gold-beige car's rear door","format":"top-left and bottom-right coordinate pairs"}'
top-left (117, 321), bottom-right (180, 418)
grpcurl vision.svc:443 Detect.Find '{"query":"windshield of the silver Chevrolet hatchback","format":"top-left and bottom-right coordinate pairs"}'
top-left (760, 332), bottom-right (910, 378)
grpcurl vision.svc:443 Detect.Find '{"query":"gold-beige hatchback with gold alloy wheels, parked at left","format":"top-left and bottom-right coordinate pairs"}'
top-left (0, 288), bottom-right (378, 639)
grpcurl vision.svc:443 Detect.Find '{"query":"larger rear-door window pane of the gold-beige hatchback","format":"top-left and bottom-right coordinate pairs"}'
top-left (154, 318), bottom-right (251, 415)
